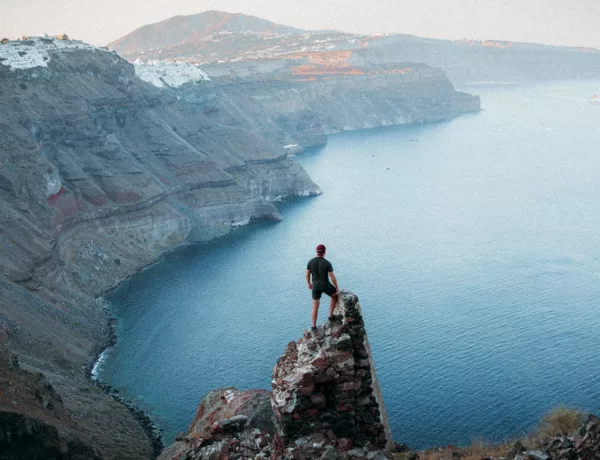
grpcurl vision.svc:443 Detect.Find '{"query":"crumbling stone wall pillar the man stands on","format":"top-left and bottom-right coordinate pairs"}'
top-left (271, 291), bottom-right (393, 454)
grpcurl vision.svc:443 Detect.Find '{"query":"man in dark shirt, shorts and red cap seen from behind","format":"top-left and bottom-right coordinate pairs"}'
top-left (306, 244), bottom-right (339, 331)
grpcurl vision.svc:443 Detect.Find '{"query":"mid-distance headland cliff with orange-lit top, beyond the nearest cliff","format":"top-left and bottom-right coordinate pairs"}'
top-left (173, 60), bottom-right (481, 153)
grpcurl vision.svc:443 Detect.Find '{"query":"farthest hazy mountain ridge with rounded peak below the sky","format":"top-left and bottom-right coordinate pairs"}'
top-left (109, 10), bottom-right (600, 83)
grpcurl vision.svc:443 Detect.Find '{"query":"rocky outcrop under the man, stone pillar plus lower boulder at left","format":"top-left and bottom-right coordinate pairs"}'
top-left (160, 291), bottom-right (395, 460)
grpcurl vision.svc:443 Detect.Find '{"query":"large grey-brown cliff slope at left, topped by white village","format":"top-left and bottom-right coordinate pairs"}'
top-left (0, 39), bottom-right (320, 458)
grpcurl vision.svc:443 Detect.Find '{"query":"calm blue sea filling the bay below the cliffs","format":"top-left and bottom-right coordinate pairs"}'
top-left (96, 81), bottom-right (600, 448)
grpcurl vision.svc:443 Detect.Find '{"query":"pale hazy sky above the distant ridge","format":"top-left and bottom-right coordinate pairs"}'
top-left (0, 0), bottom-right (600, 49)
